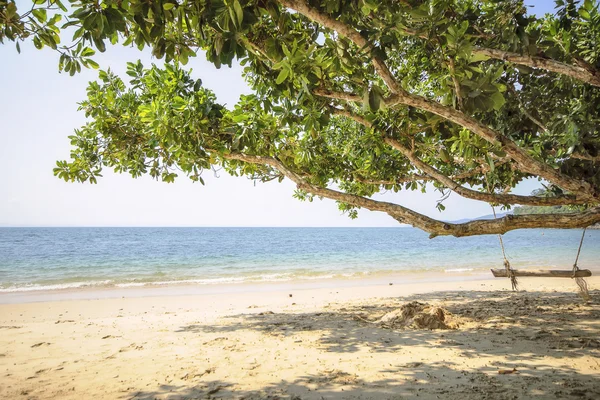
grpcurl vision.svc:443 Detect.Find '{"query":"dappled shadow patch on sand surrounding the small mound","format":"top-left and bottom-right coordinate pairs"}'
top-left (177, 291), bottom-right (600, 360)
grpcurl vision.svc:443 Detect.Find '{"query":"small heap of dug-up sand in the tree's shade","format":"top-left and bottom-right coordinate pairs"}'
top-left (361, 301), bottom-right (459, 329)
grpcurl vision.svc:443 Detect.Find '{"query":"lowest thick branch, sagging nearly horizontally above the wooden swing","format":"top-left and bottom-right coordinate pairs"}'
top-left (221, 153), bottom-right (600, 237)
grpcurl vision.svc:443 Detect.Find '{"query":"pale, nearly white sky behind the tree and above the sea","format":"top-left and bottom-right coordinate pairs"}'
top-left (0, 0), bottom-right (554, 227)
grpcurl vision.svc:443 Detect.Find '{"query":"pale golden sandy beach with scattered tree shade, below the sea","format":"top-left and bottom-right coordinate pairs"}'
top-left (0, 277), bottom-right (600, 400)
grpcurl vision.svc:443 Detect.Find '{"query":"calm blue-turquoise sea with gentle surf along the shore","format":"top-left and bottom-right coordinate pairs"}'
top-left (0, 228), bottom-right (600, 293)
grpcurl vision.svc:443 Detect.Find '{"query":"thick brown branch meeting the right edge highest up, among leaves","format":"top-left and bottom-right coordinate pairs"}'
top-left (473, 47), bottom-right (600, 87)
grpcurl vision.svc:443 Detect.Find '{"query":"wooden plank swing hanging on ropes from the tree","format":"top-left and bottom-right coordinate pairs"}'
top-left (491, 211), bottom-right (592, 300)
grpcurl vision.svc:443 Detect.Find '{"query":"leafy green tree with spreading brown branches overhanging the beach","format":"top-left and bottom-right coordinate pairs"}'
top-left (0, 0), bottom-right (600, 236)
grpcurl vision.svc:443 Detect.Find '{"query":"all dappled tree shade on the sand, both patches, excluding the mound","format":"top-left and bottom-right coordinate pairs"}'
top-left (126, 291), bottom-right (600, 400)
